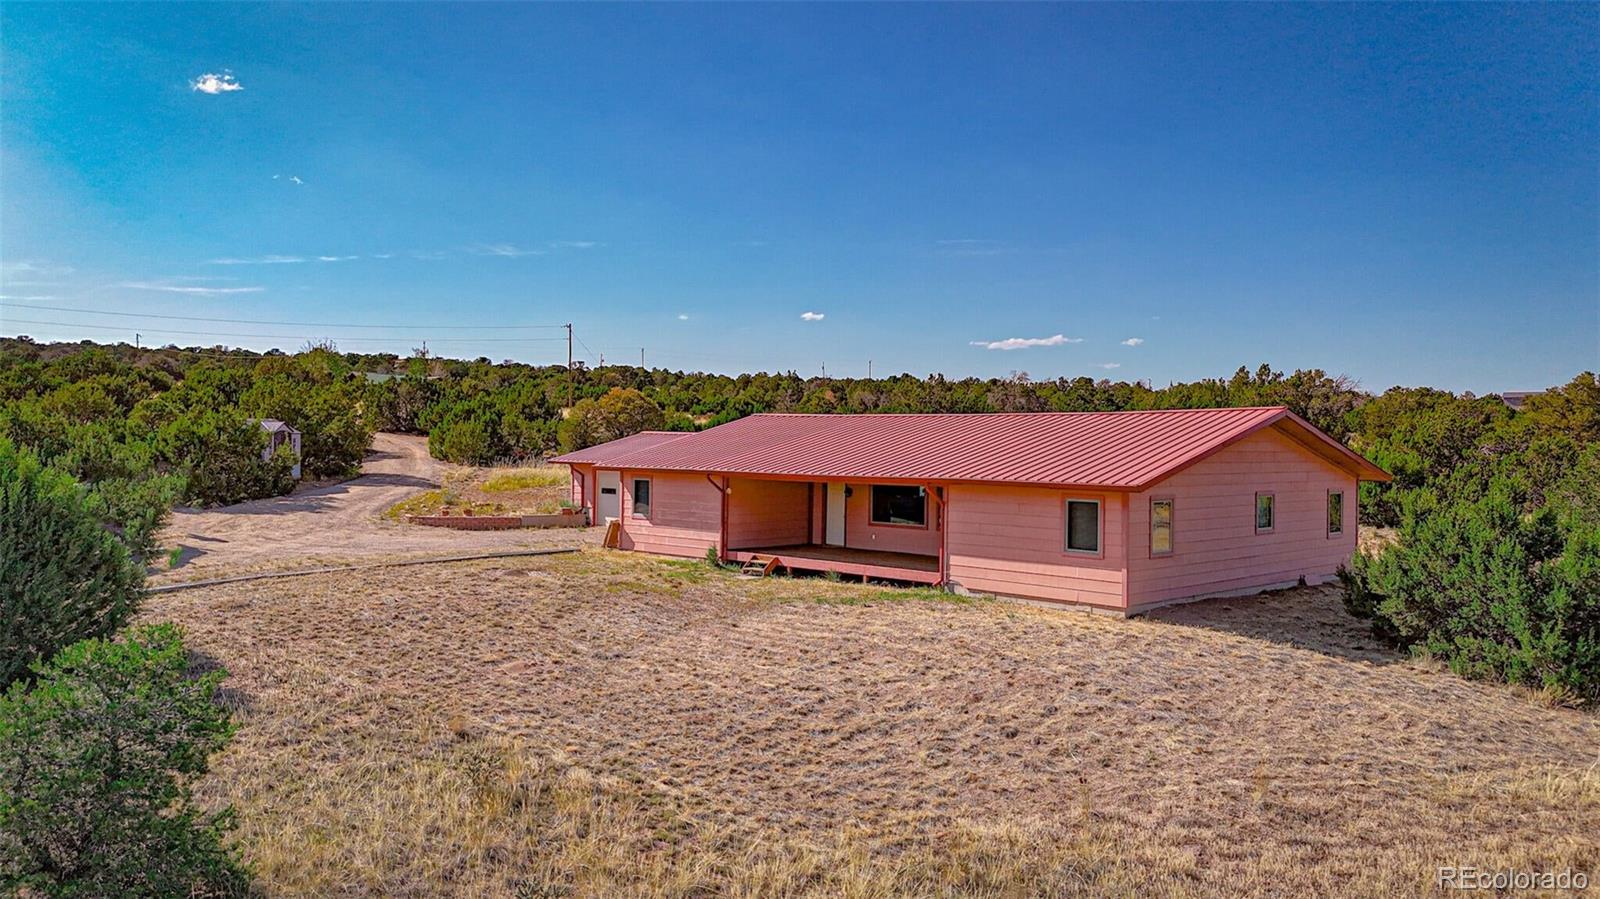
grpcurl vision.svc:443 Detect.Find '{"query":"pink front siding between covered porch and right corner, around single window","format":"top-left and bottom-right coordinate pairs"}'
top-left (946, 485), bottom-right (1126, 609)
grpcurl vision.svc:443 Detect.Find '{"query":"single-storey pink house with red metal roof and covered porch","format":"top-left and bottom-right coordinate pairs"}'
top-left (554, 406), bottom-right (1389, 614)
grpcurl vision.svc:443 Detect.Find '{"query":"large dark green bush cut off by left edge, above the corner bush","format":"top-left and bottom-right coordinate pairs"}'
top-left (0, 438), bottom-right (144, 685)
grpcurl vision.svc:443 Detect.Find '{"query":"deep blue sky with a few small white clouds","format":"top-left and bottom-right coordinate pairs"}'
top-left (0, 2), bottom-right (1600, 392)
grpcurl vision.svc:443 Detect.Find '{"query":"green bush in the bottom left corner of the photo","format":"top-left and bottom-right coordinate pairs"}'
top-left (0, 625), bottom-right (248, 897)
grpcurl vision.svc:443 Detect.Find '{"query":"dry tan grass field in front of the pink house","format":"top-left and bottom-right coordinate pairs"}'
top-left (144, 549), bottom-right (1600, 897)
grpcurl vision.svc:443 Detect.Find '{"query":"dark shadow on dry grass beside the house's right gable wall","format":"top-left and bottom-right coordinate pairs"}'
top-left (1149, 587), bottom-right (1405, 665)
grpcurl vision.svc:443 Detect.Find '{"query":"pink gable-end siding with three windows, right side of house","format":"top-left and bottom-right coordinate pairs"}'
top-left (1128, 429), bottom-right (1360, 609)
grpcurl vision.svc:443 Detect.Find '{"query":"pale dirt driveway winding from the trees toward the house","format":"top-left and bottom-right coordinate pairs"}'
top-left (152, 434), bottom-right (586, 582)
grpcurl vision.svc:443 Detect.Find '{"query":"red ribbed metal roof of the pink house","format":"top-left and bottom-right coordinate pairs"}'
top-left (555, 406), bottom-right (1389, 489)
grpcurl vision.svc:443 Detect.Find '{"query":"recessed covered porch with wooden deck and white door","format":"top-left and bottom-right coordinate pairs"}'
top-left (714, 477), bottom-right (944, 584)
